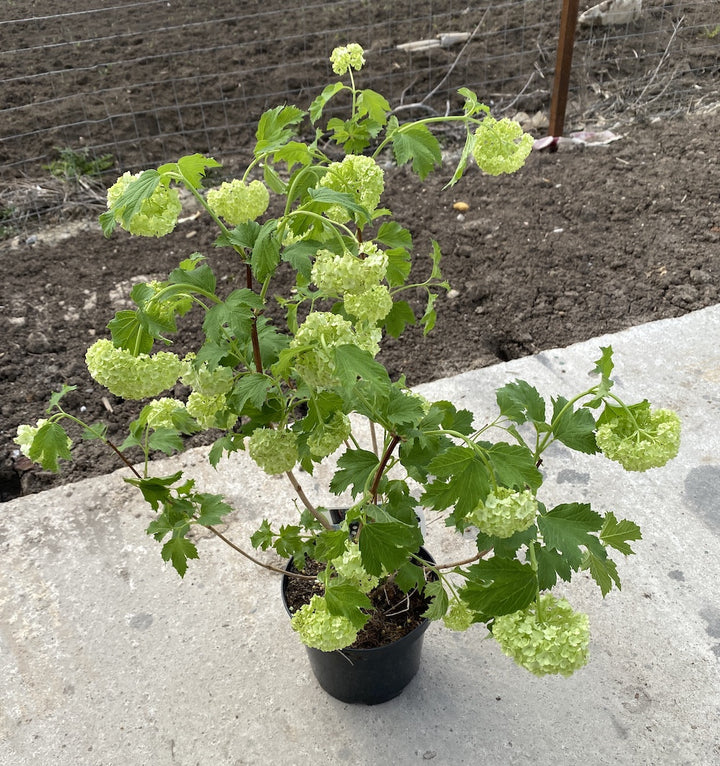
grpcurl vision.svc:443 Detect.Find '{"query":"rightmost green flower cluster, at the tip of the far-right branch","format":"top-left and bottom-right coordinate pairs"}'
top-left (595, 406), bottom-right (680, 471)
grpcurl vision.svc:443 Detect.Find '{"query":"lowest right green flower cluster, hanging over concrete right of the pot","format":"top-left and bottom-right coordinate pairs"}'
top-left (492, 594), bottom-right (590, 676)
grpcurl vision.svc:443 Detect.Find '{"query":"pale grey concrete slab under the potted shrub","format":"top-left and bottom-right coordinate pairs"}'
top-left (0, 306), bottom-right (720, 766)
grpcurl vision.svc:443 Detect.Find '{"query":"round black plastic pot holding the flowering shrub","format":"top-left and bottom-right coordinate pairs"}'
top-left (282, 548), bottom-right (434, 705)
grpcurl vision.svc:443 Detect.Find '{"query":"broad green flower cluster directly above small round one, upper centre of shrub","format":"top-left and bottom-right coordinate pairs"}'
top-left (310, 242), bottom-right (388, 298)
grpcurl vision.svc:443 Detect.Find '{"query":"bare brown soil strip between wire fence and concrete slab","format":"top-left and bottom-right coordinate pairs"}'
top-left (0, 0), bottom-right (720, 500)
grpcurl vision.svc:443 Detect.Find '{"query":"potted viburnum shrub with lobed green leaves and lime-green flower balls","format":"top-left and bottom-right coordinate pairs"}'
top-left (17, 44), bottom-right (680, 675)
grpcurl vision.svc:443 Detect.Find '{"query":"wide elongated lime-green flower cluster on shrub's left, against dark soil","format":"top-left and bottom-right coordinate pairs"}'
top-left (85, 339), bottom-right (185, 399)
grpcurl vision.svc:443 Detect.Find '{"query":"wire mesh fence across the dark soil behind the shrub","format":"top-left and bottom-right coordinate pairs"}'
top-left (0, 0), bottom-right (720, 233)
